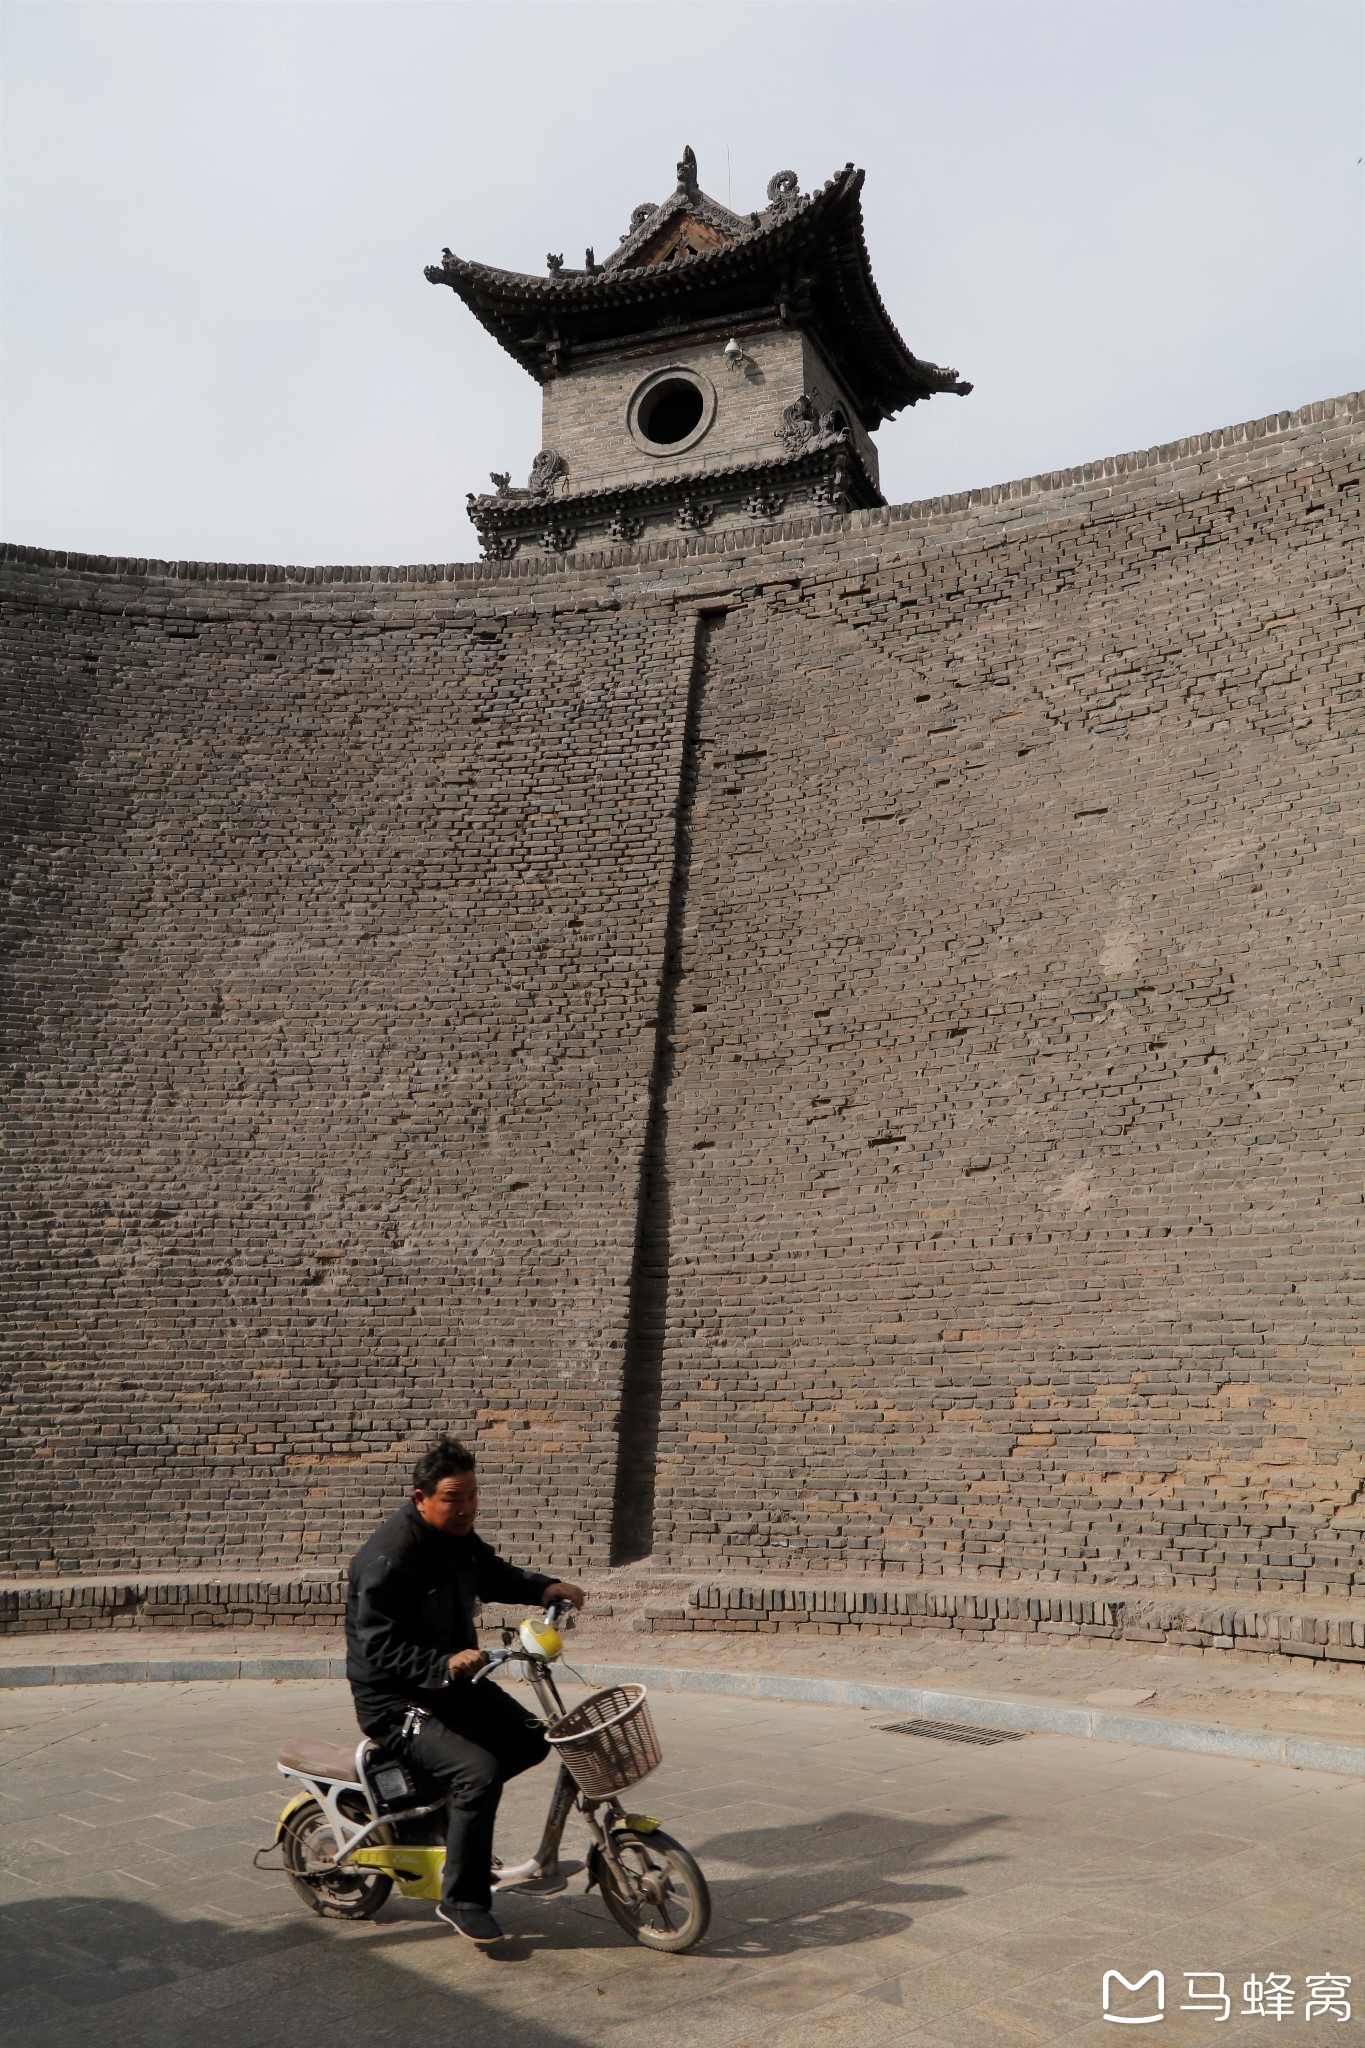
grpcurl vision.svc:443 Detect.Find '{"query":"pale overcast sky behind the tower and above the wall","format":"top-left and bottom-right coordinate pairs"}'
top-left (0, 0), bottom-right (1365, 563)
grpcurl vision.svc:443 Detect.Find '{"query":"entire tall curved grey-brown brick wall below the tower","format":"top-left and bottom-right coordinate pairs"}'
top-left (4, 397), bottom-right (1365, 1599)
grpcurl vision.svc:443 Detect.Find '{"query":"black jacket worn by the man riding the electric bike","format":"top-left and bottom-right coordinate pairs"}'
top-left (346, 1501), bottom-right (555, 1735)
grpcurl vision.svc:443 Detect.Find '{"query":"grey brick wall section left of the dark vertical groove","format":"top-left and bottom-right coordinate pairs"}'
top-left (2, 563), bottom-right (692, 1571)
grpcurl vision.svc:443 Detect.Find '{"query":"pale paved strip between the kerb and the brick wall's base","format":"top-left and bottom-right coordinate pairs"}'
top-left (0, 1608), bottom-right (1365, 1743)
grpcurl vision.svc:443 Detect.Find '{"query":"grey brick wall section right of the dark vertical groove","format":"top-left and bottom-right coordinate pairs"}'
top-left (657, 403), bottom-right (1365, 1593)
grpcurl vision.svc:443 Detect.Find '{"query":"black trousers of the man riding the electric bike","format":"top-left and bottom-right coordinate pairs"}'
top-left (394, 1679), bottom-right (548, 1913)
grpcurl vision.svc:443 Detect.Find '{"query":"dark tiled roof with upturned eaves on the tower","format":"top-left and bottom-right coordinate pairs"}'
top-left (426, 152), bottom-right (972, 430)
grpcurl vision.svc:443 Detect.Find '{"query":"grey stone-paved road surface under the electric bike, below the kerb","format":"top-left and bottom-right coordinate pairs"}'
top-left (0, 1681), bottom-right (1365, 2048)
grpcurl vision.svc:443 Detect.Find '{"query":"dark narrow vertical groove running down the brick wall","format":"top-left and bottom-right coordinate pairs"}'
top-left (612, 612), bottom-right (726, 1565)
